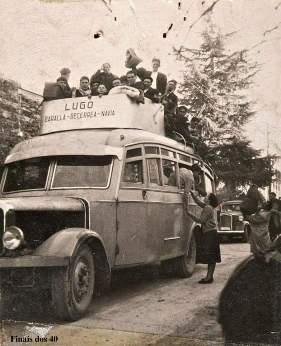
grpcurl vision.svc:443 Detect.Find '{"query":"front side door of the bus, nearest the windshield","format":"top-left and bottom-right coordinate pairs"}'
top-left (115, 146), bottom-right (148, 266)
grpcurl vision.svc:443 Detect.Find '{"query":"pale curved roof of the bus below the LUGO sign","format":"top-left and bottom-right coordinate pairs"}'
top-left (5, 129), bottom-right (197, 163)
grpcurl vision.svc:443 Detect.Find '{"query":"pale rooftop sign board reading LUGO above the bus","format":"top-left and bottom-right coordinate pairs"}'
top-left (41, 94), bottom-right (164, 135)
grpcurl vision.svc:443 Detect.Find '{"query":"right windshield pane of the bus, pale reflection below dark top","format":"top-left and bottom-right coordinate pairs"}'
top-left (52, 156), bottom-right (112, 188)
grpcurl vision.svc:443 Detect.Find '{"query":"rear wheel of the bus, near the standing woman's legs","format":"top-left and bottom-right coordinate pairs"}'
top-left (161, 235), bottom-right (196, 278)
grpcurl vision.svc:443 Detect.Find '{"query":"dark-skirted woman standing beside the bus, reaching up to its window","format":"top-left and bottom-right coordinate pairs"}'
top-left (184, 191), bottom-right (221, 284)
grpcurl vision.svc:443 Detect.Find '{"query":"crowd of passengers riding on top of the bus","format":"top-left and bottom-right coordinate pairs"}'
top-left (44, 49), bottom-right (205, 149)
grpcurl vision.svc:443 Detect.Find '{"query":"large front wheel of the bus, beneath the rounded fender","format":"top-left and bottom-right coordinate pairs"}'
top-left (52, 245), bottom-right (95, 321)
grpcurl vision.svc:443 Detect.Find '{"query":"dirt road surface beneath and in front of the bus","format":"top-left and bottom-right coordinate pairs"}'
top-left (0, 243), bottom-right (249, 346)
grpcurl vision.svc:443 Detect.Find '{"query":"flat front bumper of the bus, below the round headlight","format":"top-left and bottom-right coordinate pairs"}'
top-left (0, 255), bottom-right (70, 270)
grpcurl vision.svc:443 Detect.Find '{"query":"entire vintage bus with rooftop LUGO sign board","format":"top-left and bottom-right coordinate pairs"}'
top-left (0, 94), bottom-right (214, 320)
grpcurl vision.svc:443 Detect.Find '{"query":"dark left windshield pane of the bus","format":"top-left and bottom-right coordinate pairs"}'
top-left (3, 157), bottom-right (50, 192)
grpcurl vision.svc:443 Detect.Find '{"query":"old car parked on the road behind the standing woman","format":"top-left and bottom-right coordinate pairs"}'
top-left (219, 200), bottom-right (250, 241)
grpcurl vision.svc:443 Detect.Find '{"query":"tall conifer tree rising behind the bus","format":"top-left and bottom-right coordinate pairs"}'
top-left (175, 25), bottom-right (272, 195)
